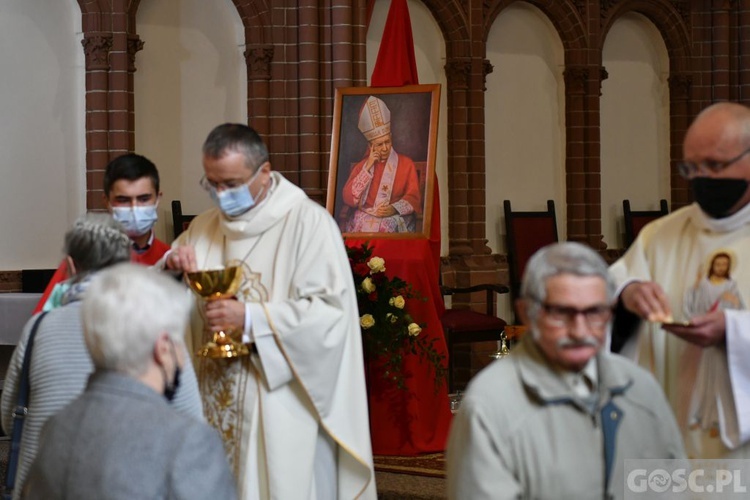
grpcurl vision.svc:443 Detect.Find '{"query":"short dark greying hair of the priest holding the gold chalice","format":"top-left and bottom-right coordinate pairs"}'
top-left (203, 123), bottom-right (268, 172)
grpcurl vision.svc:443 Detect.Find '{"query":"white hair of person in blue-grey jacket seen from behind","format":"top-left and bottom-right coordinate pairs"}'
top-left (81, 263), bottom-right (192, 377)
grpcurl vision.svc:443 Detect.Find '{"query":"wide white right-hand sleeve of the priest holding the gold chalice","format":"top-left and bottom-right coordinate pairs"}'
top-left (251, 210), bottom-right (362, 409)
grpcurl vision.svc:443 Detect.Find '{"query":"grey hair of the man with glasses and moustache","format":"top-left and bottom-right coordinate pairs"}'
top-left (521, 242), bottom-right (616, 321)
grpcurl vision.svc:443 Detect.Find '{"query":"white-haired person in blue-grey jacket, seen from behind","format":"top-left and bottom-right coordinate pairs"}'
top-left (24, 263), bottom-right (237, 500)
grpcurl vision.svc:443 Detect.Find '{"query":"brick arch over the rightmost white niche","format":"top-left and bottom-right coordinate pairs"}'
top-left (599, 0), bottom-right (692, 73)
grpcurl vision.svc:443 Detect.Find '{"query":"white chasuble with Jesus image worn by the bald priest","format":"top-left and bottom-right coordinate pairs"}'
top-left (610, 204), bottom-right (750, 458)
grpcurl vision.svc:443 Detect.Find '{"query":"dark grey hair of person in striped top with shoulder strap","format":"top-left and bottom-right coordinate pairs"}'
top-left (64, 213), bottom-right (131, 279)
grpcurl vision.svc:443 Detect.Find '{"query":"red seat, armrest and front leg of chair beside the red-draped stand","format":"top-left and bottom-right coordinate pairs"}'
top-left (440, 283), bottom-right (510, 392)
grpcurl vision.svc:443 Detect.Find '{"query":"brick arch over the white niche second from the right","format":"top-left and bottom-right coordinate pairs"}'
top-left (484, 0), bottom-right (589, 54)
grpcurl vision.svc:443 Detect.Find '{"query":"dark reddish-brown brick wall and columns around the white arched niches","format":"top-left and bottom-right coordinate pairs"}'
top-left (5, 0), bottom-right (750, 300)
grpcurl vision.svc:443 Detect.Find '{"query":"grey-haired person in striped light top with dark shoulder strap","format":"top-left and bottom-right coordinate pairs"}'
top-left (0, 214), bottom-right (203, 500)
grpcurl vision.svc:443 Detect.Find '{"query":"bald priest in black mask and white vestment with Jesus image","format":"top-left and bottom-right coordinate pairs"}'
top-left (611, 103), bottom-right (750, 458)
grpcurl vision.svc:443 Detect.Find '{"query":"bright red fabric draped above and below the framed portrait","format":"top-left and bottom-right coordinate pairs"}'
top-left (358, 0), bottom-right (452, 455)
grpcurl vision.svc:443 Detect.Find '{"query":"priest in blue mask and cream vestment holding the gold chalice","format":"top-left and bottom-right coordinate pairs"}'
top-left (163, 124), bottom-right (376, 500)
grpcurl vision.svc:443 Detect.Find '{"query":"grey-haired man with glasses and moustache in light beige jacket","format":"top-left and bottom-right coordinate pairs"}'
top-left (448, 243), bottom-right (684, 500)
